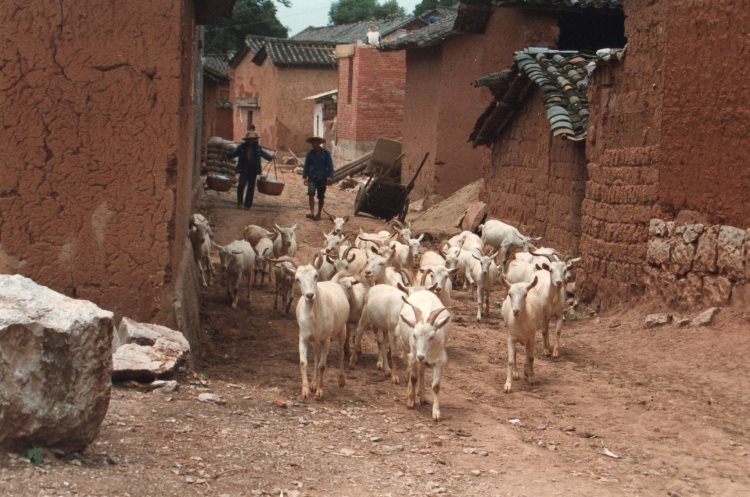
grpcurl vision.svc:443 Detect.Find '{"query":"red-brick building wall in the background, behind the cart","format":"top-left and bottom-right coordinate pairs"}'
top-left (337, 45), bottom-right (406, 158)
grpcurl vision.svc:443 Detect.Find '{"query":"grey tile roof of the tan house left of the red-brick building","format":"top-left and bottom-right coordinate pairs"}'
top-left (253, 38), bottom-right (336, 69)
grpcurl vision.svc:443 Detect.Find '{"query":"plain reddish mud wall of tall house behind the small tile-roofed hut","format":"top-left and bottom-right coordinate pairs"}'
top-left (401, 8), bottom-right (558, 198)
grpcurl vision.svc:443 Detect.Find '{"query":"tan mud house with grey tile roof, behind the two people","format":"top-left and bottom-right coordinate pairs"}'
top-left (230, 35), bottom-right (337, 153)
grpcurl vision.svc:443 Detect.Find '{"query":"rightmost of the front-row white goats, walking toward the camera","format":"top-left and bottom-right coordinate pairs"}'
top-left (500, 278), bottom-right (544, 393)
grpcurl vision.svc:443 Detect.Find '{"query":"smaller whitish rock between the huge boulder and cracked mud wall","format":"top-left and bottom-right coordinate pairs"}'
top-left (112, 318), bottom-right (190, 382)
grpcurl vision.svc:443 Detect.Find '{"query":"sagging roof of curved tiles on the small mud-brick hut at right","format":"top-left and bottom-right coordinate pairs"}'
top-left (469, 48), bottom-right (624, 146)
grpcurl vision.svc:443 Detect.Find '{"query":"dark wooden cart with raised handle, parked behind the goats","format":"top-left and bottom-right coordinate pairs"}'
top-left (354, 152), bottom-right (430, 222)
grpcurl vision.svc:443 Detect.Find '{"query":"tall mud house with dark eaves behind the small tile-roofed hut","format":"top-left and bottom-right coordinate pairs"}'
top-left (382, 0), bottom-right (623, 202)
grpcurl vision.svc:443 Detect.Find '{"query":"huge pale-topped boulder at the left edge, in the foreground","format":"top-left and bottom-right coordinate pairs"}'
top-left (0, 275), bottom-right (113, 451)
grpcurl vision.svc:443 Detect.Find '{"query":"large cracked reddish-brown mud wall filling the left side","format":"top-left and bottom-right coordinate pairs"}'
top-left (0, 0), bottom-right (200, 330)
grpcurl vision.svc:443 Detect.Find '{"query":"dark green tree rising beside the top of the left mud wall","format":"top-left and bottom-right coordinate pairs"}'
top-left (205, 0), bottom-right (291, 53)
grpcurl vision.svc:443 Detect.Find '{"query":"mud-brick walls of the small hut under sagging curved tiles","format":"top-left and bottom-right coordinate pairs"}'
top-left (484, 90), bottom-right (586, 255)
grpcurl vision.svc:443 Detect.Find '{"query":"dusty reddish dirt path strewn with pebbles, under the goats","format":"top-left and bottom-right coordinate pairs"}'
top-left (0, 168), bottom-right (750, 497)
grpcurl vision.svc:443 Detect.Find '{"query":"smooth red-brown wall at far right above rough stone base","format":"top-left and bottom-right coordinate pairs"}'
top-left (660, 0), bottom-right (750, 228)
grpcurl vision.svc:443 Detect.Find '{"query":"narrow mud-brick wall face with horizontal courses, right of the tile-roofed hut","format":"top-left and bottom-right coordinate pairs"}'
top-left (578, 0), bottom-right (669, 304)
